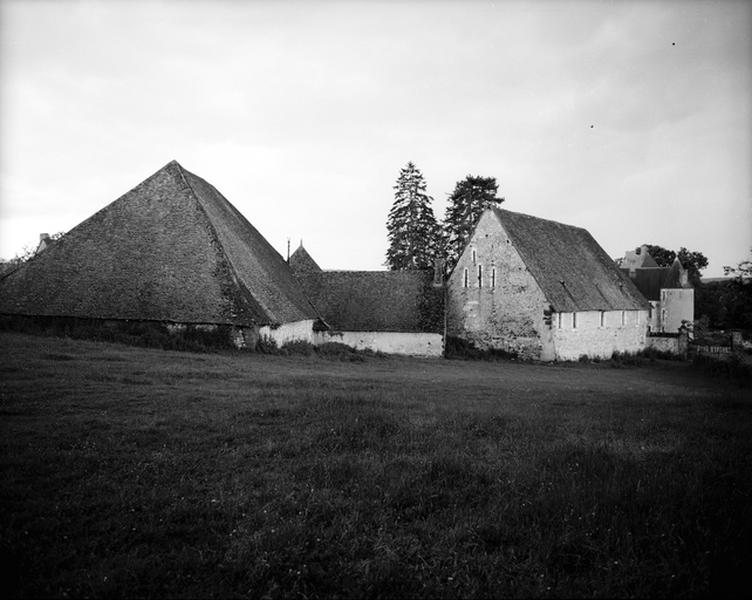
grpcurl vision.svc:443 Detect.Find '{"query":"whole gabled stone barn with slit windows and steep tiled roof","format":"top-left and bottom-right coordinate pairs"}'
top-left (447, 208), bottom-right (649, 361)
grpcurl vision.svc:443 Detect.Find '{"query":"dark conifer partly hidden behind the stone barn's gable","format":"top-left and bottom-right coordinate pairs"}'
top-left (444, 175), bottom-right (504, 270)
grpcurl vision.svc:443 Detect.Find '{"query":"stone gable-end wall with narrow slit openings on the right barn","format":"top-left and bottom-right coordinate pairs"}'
top-left (447, 212), bottom-right (554, 360)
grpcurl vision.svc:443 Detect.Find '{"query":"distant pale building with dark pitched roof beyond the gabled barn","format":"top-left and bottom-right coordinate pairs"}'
top-left (621, 246), bottom-right (695, 333)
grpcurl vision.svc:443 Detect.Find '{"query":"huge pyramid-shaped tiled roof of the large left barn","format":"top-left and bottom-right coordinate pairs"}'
top-left (0, 161), bottom-right (318, 325)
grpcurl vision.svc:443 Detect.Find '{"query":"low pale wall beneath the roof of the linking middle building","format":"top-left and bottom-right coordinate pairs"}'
top-left (314, 331), bottom-right (444, 357)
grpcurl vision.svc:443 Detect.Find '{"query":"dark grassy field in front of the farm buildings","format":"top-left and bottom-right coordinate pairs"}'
top-left (0, 333), bottom-right (752, 598)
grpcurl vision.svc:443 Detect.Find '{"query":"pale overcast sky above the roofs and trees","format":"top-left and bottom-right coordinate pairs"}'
top-left (0, 0), bottom-right (752, 276)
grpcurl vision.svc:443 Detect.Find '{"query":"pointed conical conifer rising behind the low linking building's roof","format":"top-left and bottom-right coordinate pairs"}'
top-left (386, 162), bottom-right (441, 271)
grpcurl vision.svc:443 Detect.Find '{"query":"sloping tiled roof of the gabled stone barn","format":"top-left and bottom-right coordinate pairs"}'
top-left (490, 208), bottom-right (649, 312)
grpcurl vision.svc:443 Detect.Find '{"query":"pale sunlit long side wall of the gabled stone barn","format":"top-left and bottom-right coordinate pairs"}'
top-left (552, 310), bottom-right (648, 360)
